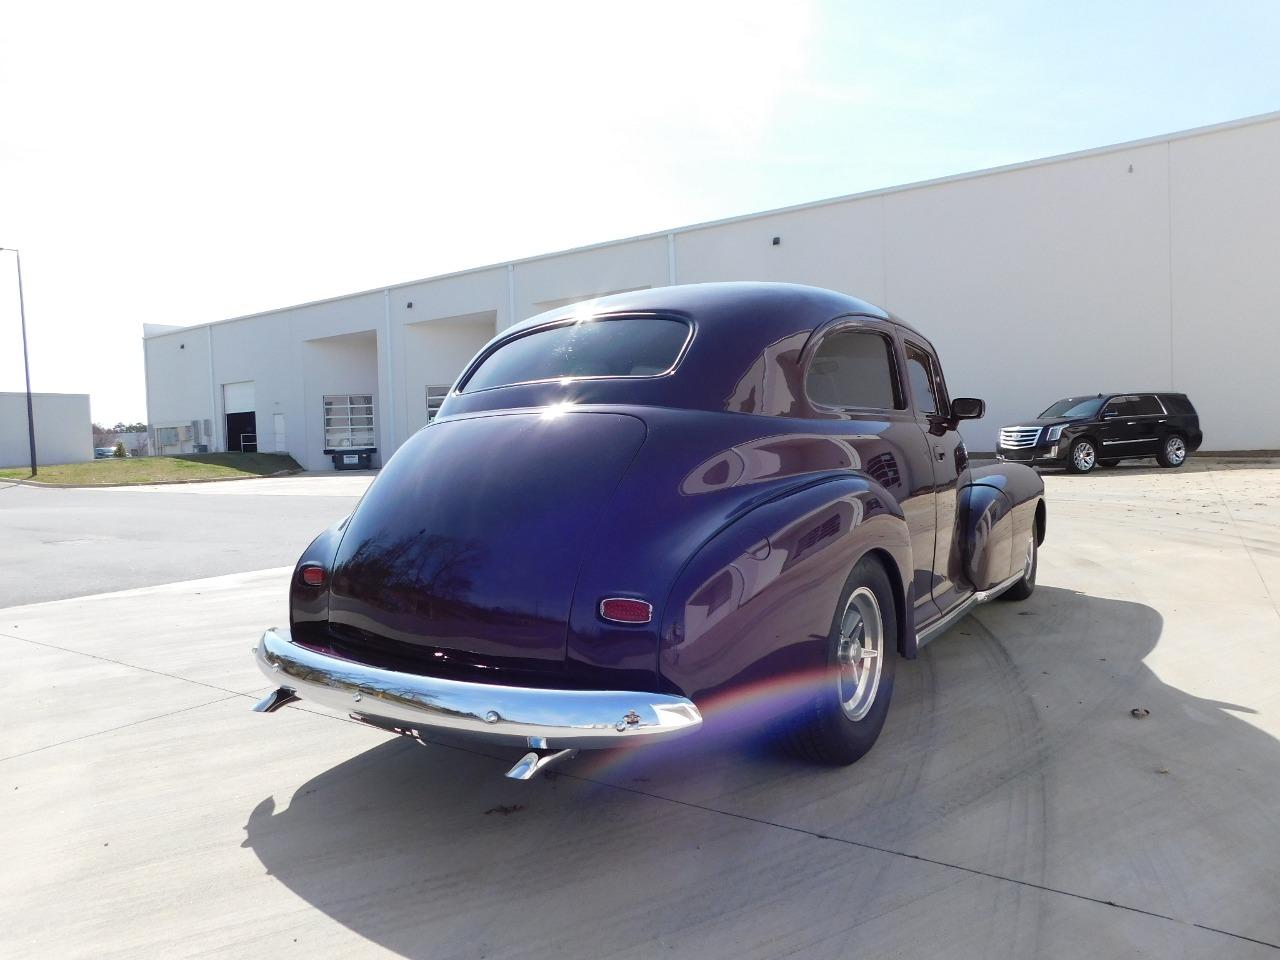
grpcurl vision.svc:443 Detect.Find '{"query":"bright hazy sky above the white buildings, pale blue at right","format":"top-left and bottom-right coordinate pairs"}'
top-left (0, 0), bottom-right (1280, 425)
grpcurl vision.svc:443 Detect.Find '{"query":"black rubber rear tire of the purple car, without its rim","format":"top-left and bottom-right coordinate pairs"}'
top-left (787, 557), bottom-right (897, 765)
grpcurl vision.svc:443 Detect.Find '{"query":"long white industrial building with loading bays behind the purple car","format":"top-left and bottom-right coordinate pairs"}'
top-left (145, 113), bottom-right (1280, 468)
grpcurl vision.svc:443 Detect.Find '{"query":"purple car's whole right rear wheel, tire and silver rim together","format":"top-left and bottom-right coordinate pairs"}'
top-left (790, 557), bottom-right (897, 765)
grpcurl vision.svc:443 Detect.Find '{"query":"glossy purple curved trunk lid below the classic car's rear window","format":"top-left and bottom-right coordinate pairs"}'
top-left (329, 408), bottom-right (645, 682)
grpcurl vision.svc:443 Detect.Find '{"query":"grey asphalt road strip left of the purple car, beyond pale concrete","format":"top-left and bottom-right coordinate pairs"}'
top-left (0, 474), bottom-right (369, 607)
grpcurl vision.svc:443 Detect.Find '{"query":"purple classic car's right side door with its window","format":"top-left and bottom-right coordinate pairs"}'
top-left (902, 334), bottom-right (969, 612)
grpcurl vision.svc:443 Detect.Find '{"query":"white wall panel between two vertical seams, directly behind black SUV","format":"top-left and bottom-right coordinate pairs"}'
top-left (881, 145), bottom-right (1170, 451)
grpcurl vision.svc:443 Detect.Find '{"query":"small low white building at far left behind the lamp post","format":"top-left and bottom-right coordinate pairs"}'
top-left (0, 393), bottom-right (93, 467)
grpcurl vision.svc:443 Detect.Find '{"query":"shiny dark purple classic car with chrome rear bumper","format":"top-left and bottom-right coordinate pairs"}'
top-left (255, 283), bottom-right (1046, 780)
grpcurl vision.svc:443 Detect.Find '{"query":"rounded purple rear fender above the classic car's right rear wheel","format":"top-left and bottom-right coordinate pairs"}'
top-left (659, 477), bottom-right (914, 696)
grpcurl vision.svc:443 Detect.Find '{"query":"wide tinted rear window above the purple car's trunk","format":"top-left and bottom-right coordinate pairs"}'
top-left (462, 316), bottom-right (692, 393)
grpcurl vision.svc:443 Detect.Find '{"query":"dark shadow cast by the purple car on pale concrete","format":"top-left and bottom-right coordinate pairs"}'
top-left (244, 585), bottom-right (1280, 957)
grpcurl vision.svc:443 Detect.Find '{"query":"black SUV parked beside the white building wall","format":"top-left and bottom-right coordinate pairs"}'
top-left (996, 393), bottom-right (1203, 474)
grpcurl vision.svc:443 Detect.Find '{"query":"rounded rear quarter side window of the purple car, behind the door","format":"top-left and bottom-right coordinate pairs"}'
top-left (804, 330), bottom-right (906, 410)
